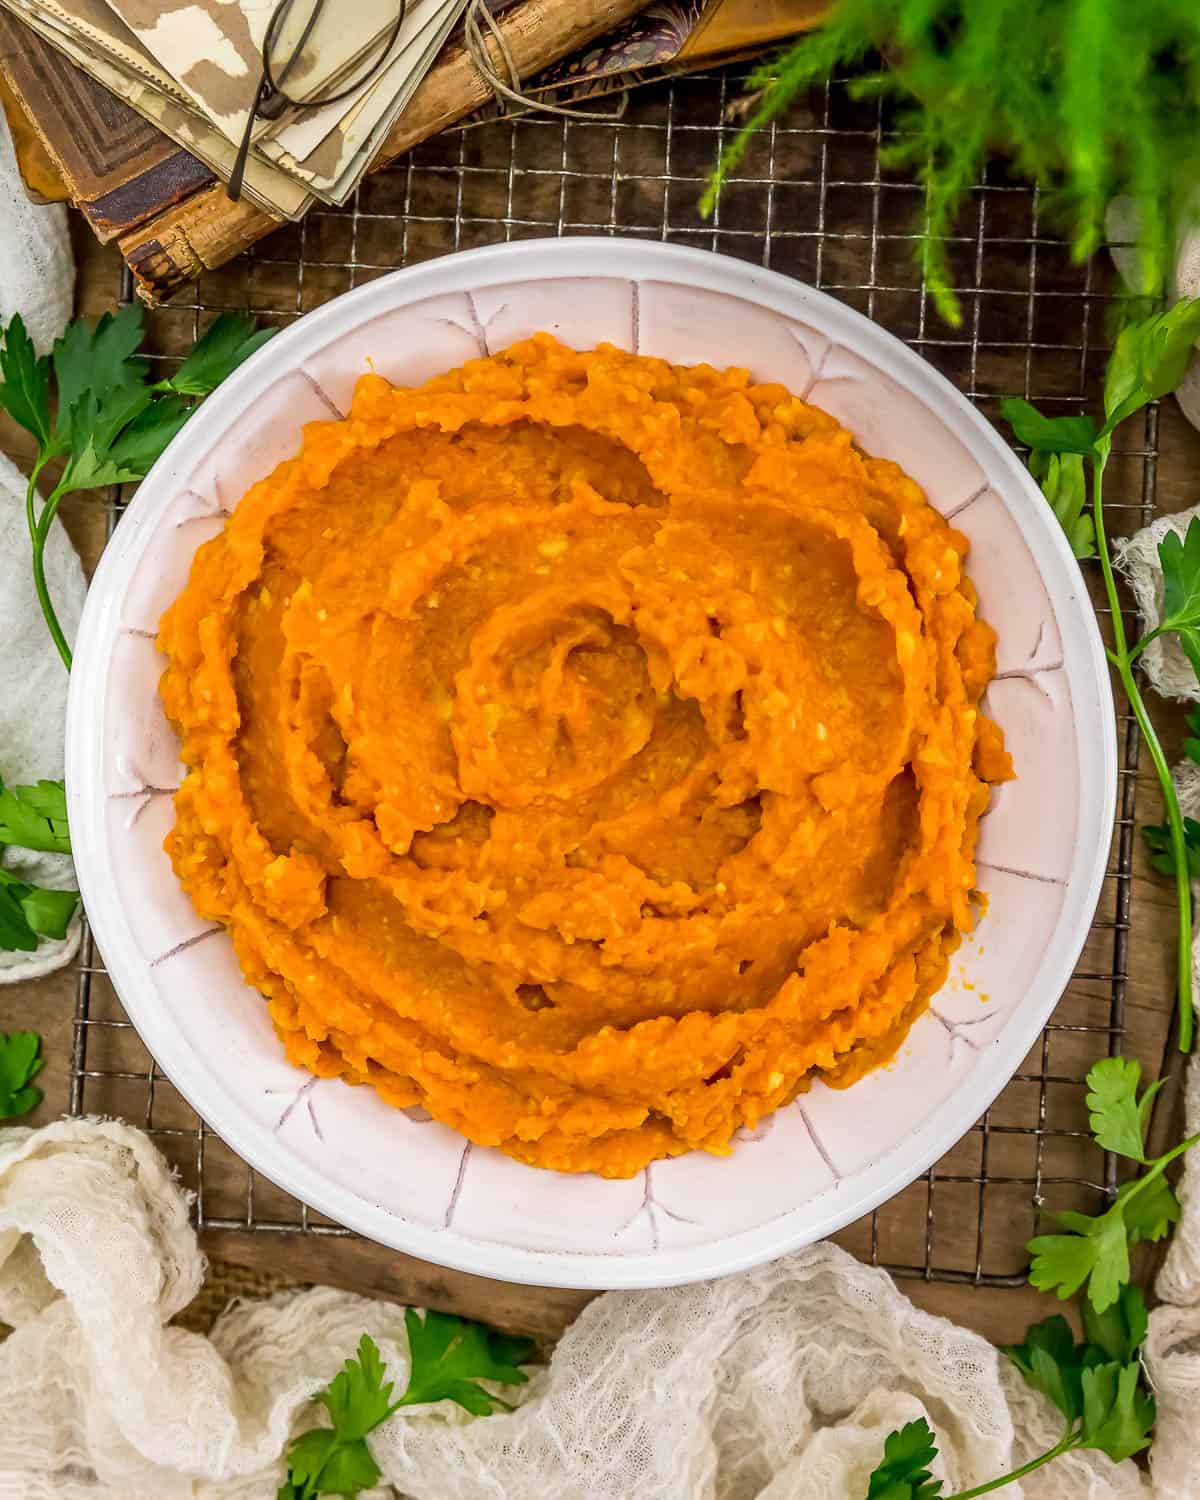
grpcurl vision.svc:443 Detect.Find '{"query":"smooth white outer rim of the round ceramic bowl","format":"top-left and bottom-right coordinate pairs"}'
top-left (66, 236), bottom-right (1118, 1289)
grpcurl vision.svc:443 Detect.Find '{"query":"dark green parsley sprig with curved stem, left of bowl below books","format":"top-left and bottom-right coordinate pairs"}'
top-left (0, 306), bottom-right (276, 671)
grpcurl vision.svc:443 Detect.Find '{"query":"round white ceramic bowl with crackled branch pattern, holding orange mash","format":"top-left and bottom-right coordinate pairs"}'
top-left (68, 239), bottom-right (1116, 1287)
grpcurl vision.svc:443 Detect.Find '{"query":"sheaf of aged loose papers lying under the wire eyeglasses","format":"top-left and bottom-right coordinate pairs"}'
top-left (3, 0), bottom-right (480, 219)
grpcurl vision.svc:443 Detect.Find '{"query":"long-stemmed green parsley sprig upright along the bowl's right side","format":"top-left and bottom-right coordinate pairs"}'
top-left (1002, 299), bottom-right (1200, 1052)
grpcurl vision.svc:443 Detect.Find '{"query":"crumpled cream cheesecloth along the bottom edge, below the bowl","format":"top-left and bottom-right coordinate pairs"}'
top-left (0, 1121), bottom-right (1170, 1500)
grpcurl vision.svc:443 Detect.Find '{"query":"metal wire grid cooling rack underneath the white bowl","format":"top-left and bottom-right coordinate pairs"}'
top-left (71, 74), bottom-right (1158, 1286)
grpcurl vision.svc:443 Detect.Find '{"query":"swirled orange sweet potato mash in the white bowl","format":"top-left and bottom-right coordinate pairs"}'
top-left (159, 336), bottom-right (1011, 1178)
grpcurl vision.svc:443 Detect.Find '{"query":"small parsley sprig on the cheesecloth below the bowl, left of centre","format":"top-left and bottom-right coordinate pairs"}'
top-left (278, 1308), bottom-right (534, 1500)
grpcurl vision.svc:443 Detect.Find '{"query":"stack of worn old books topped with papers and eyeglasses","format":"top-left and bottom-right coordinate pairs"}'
top-left (0, 0), bottom-right (825, 302)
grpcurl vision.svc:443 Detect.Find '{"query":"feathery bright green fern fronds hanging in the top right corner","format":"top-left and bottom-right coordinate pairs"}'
top-left (701, 0), bottom-right (1200, 323)
